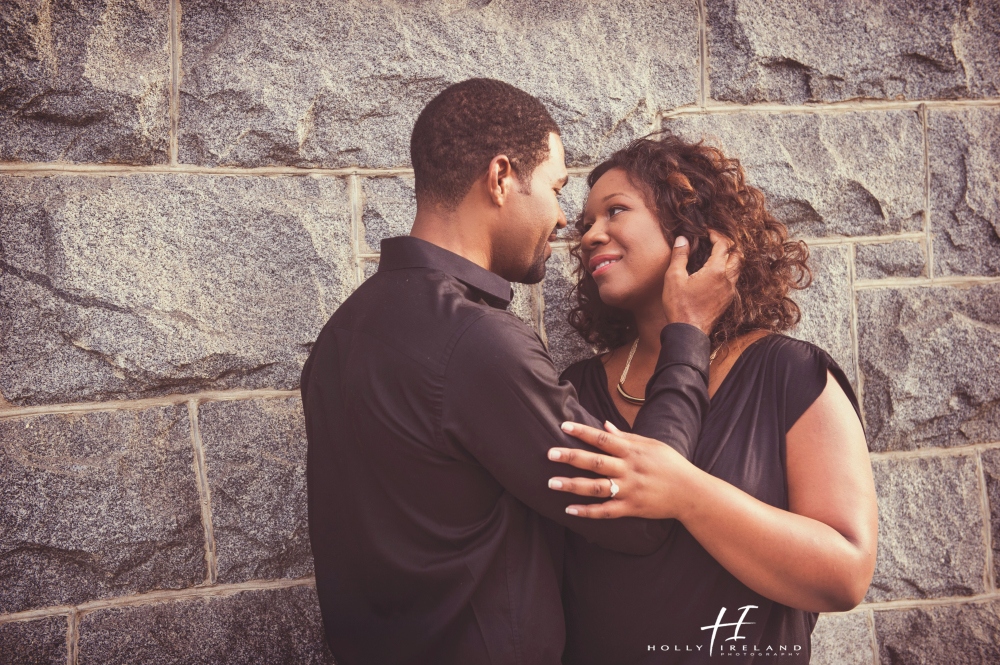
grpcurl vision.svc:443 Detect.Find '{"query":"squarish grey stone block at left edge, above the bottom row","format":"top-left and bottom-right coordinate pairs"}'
top-left (0, 406), bottom-right (206, 614)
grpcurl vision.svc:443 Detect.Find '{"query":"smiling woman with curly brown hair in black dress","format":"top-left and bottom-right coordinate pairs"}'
top-left (549, 134), bottom-right (877, 665)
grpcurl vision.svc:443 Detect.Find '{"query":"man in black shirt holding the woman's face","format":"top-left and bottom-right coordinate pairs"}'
top-left (302, 79), bottom-right (732, 665)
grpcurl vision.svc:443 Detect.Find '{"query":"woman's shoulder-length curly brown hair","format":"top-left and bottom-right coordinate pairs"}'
top-left (569, 130), bottom-right (812, 350)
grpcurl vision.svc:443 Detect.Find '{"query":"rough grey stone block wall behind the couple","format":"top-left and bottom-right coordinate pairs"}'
top-left (0, 0), bottom-right (1000, 664)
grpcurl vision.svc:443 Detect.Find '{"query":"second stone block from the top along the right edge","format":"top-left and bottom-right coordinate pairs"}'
top-left (928, 107), bottom-right (1000, 276)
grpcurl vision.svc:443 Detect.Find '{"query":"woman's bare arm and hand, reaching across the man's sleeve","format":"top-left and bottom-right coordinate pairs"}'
top-left (549, 374), bottom-right (878, 612)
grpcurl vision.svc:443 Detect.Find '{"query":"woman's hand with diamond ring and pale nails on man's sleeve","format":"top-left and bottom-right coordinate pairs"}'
top-left (549, 422), bottom-right (703, 519)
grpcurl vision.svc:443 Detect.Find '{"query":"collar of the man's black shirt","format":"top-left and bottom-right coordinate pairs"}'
top-left (378, 236), bottom-right (514, 309)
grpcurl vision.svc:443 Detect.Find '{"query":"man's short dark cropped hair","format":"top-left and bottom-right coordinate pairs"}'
top-left (410, 78), bottom-right (559, 209)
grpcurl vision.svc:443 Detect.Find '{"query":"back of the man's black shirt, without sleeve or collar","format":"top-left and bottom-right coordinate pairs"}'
top-left (302, 239), bottom-right (564, 663)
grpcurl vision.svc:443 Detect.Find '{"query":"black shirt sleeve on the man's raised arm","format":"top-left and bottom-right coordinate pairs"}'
top-left (440, 312), bottom-right (708, 554)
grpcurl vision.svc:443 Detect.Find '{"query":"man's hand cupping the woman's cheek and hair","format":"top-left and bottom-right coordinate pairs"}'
top-left (663, 231), bottom-right (740, 335)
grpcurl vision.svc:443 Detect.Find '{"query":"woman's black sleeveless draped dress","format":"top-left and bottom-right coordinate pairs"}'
top-left (562, 335), bottom-right (858, 665)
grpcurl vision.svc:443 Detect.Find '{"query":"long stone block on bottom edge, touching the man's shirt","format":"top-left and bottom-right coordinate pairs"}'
top-left (77, 587), bottom-right (334, 665)
